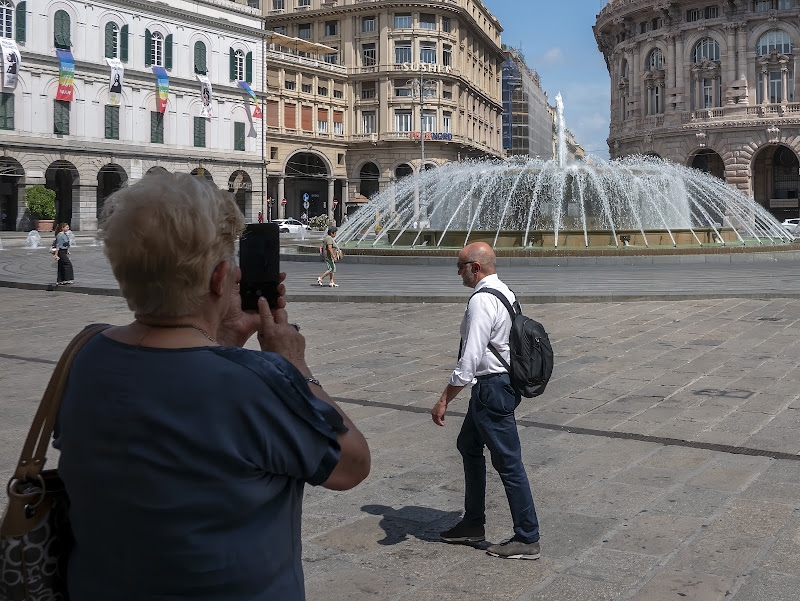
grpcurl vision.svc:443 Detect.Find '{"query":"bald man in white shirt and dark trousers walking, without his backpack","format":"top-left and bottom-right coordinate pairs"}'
top-left (431, 242), bottom-right (539, 559)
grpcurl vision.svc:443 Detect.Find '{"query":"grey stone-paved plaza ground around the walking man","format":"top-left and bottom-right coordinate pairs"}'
top-left (0, 249), bottom-right (800, 601)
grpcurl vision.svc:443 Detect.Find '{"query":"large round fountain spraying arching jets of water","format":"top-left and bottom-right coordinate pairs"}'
top-left (338, 95), bottom-right (792, 249)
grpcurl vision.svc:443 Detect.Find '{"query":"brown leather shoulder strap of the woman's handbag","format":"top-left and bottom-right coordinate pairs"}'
top-left (14, 323), bottom-right (111, 482)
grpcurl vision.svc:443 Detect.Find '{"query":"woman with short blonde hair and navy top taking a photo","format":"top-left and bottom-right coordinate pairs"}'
top-left (54, 174), bottom-right (370, 601)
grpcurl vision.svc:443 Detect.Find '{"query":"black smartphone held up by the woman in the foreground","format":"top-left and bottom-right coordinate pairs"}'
top-left (239, 223), bottom-right (281, 311)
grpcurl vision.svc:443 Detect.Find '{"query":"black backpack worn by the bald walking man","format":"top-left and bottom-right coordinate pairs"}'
top-left (475, 288), bottom-right (553, 398)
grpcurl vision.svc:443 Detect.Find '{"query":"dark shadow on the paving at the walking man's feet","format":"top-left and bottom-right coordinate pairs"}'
top-left (361, 505), bottom-right (488, 548)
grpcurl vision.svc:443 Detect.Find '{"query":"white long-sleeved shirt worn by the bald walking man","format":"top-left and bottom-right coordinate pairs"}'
top-left (450, 274), bottom-right (517, 387)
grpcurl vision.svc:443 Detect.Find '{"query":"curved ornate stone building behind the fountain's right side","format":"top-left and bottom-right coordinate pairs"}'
top-left (594, 0), bottom-right (800, 219)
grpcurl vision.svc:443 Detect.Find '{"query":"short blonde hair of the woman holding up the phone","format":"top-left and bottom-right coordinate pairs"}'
top-left (101, 173), bottom-right (244, 317)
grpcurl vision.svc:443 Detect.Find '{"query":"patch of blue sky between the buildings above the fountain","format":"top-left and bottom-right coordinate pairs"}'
top-left (483, 0), bottom-right (610, 159)
